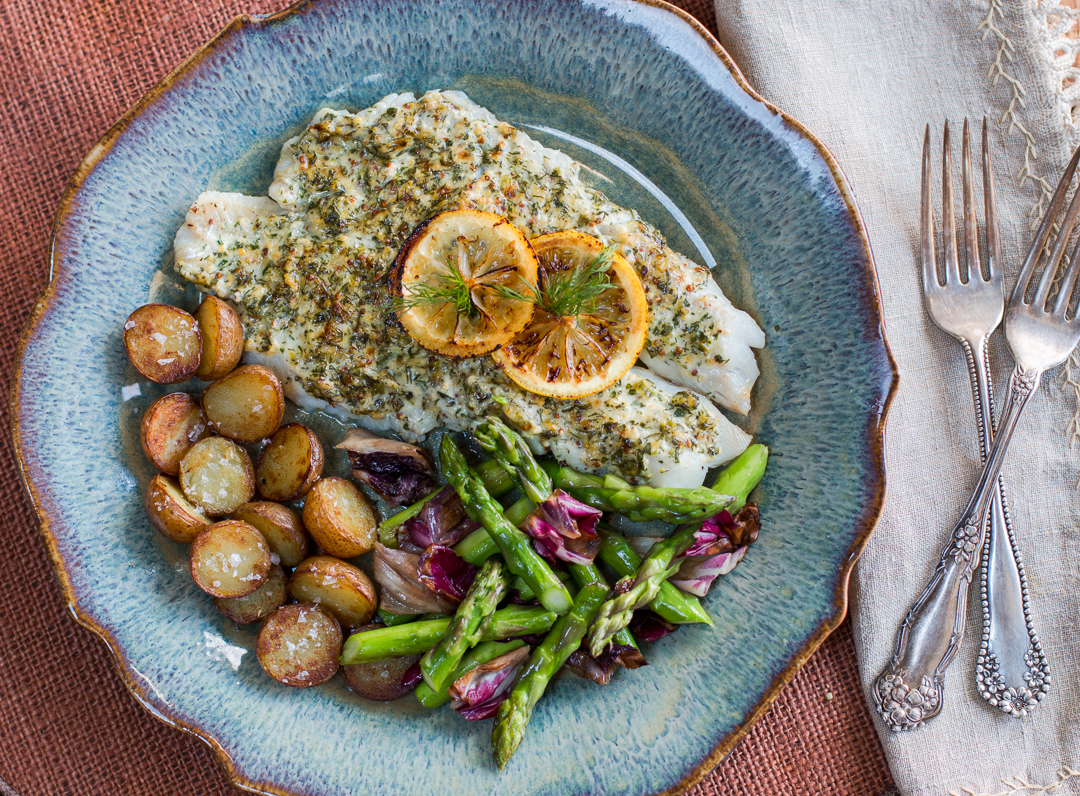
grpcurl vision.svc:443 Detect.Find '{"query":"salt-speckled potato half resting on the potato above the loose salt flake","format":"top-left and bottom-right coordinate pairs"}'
top-left (191, 520), bottom-right (270, 597)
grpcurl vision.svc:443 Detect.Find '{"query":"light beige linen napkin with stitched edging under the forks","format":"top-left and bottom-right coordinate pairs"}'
top-left (716, 0), bottom-right (1080, 796)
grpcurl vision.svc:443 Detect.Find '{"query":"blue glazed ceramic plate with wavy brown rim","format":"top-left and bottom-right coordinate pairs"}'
top-left (12, 0), bottom-right (896, 796)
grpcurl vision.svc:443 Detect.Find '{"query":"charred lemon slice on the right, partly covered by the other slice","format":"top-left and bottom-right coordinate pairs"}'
top-left (492, 232), bottom-right (648, 399)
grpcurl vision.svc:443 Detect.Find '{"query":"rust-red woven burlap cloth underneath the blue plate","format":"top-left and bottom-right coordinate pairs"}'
top-left (0, 0), bottom-right (892, 796)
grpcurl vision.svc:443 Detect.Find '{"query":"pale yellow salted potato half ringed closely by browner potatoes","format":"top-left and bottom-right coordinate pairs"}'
top-left (180, 436), bottom-right (255, 516)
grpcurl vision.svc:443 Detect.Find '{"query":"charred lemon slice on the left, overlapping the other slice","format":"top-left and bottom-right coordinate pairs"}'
top-left (392, 210), bottom-right (537, 356)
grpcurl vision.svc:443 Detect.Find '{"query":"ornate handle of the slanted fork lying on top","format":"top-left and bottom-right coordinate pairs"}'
top-left (873, 367), bottom-right (1042, 732)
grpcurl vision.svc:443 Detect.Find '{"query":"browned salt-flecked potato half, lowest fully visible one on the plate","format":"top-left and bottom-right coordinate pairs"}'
top-left (256, 603), bottom-right (342, 688)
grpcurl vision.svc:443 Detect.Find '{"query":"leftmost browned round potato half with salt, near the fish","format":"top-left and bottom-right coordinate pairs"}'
top-left (124, 303), bottom-right (202, 384)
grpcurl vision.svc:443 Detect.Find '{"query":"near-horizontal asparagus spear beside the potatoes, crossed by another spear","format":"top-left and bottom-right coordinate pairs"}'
top-left (340, 605), bottom-right (557, 665)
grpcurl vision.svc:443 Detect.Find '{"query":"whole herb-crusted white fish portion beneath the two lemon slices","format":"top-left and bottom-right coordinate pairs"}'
top-left (175, 90), bottom-right (760, 486)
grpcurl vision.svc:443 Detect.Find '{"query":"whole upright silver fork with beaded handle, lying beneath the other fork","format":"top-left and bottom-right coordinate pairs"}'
top-left (920, 119), bottom-right (1050, 717)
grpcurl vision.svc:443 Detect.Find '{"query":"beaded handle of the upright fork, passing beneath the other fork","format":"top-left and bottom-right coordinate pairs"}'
top-left (964, 339), bottom-right (1051, 718)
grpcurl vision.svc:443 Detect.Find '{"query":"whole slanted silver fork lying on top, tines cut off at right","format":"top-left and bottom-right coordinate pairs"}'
top-left (873, 139), bottom-right (1080, 732)
